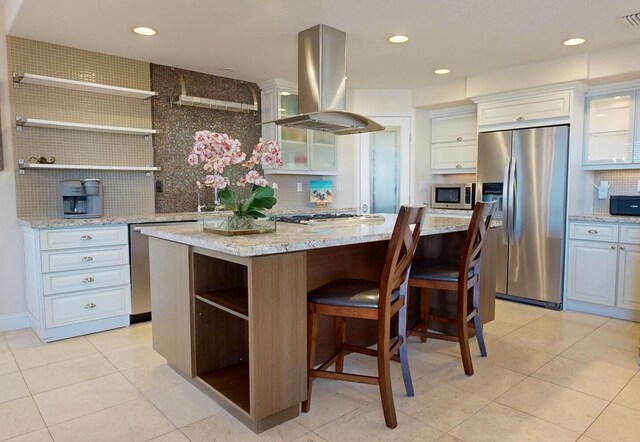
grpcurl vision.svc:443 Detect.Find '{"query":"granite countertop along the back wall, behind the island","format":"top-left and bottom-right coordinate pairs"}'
top-left (18, 207), bottom-right (357, 229)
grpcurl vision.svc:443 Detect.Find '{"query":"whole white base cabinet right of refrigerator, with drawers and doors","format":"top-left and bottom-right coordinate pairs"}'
top-left (567, 222), bottom-right (640, 313)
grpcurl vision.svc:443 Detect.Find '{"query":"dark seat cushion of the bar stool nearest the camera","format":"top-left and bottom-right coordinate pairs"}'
top-left (307, 279), bottom-right (400, 308)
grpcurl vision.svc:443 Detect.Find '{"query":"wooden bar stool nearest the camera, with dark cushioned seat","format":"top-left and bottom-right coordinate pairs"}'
top-left (302, 206), bottom-right (425, 428)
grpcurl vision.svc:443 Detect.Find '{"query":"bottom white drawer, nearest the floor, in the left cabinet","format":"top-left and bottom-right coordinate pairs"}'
top-left (44, 286), bottom-right (131, 328)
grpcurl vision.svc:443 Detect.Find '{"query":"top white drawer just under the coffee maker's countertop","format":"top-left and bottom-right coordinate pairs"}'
top-left (40, 226), bottom-right (129, 250)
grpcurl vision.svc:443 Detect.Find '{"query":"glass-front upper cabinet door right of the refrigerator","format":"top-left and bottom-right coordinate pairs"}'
top-left (583, 90), bottom-right (640, 169)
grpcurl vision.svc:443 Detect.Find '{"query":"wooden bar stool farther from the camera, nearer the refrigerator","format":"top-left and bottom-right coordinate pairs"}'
top-left (407, 202), bottom-right (495, 376)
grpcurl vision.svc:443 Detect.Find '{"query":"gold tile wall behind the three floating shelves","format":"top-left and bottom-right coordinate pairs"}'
top-left (9, 36), bottom-right (154, 218)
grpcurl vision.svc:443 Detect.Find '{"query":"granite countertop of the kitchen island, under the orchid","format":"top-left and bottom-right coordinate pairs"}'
top-left (141, 214), bottom-right (500, 257)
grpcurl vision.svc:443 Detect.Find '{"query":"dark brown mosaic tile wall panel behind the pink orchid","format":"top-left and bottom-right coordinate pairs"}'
top-left (151, 64), bottom-right (261, 213)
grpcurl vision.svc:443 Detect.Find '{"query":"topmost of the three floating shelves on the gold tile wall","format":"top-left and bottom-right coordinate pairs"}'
top-left (13, 72), bottom-right (158, 100)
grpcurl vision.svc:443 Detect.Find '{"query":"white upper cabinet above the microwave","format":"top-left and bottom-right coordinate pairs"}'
top-left (430, 107), bottom-right (478, 174)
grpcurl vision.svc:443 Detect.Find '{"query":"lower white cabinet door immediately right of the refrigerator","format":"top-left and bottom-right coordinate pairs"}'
top-left (567, 241), bottom-right (618, 306)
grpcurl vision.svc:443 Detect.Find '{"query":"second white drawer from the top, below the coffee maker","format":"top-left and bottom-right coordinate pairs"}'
top-left (41, 245), bottom-right (129, 273)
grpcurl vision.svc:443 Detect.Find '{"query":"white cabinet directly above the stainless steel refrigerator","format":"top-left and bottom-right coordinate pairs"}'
top-left (478, 91), bottom-right (571, 130)
